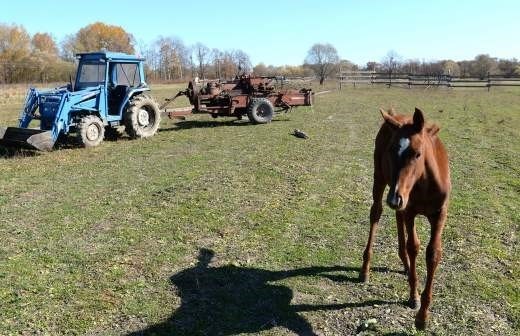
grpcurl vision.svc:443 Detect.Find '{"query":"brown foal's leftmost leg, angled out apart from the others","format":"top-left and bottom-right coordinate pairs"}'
top-left (359, 175), bottom-right (386, 282)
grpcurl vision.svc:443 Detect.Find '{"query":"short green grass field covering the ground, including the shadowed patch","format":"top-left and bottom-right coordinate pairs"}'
top-left (0, 85), bottom-right (520, 335)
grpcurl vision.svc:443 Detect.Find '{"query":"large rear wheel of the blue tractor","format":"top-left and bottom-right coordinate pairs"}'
top-left (124, 95), bottom-right (161, 139)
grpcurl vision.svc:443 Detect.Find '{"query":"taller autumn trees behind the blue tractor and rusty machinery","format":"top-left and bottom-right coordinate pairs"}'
top-left (0, 22), bottom-right (252, 83)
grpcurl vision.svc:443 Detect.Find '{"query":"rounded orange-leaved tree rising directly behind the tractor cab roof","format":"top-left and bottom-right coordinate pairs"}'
top-left (73, 22), bottom-right (134, 54)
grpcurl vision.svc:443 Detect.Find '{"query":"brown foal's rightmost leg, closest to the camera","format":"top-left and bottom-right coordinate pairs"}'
top-left (415, 208), bottom-right (447, 330)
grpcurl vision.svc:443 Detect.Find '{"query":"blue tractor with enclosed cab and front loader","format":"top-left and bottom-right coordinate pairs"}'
top-left (0, 52), bottom-right (161, 151)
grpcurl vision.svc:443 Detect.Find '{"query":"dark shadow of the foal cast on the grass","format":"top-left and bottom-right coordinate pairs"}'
top-left (128, 249), bottom-right (402, 336)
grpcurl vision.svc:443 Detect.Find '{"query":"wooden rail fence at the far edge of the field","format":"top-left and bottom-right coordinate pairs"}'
top-left (337, 71), bottom-right (520, 91)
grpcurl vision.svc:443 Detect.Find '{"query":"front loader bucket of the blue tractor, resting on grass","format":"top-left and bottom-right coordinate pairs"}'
top-left (0, 127), bottom-right (55, 151)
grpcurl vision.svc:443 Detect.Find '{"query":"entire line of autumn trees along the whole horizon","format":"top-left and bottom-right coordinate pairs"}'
top-left (0, 22), bottom-right (520, 84)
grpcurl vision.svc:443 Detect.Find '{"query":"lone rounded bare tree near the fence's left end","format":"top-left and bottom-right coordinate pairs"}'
top-left (305, 43), bottom-right (339, 85)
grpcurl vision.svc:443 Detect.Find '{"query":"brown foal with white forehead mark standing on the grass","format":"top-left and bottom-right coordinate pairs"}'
top-left (360, 108), bottom-right (451, 329)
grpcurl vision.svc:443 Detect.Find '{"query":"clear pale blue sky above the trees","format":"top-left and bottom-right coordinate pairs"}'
top-left (0, 0), bottom-right (520, 65)
